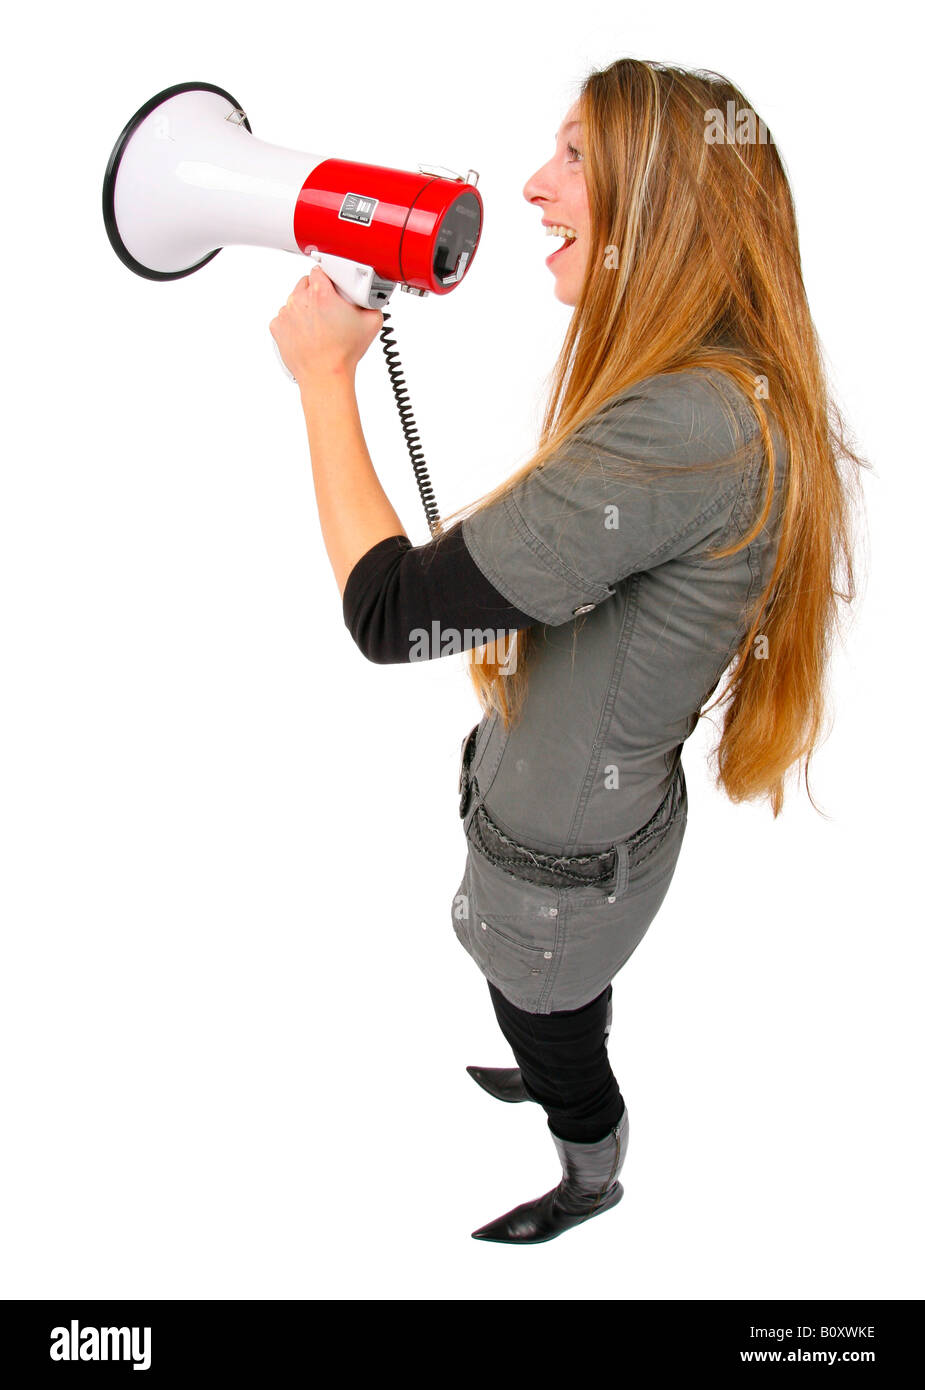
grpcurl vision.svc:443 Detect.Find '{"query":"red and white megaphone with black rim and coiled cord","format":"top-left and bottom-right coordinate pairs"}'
top-left (103, 82), bottom-right (483, 531)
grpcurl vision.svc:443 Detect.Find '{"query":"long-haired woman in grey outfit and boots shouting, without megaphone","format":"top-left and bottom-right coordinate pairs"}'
top-left (270, 58), bottom-right (864, 1243)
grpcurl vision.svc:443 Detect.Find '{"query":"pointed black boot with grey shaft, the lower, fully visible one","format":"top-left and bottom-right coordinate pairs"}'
top-left (472, 1109), bottom-right (630, 1245)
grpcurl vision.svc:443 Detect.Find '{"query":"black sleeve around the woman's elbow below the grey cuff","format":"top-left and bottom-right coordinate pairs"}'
top-left (344, 523), bottom-right (537, 666)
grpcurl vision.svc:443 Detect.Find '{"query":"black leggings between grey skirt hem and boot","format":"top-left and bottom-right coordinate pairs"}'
top-left (485, 980), bottom-right (625, 1144)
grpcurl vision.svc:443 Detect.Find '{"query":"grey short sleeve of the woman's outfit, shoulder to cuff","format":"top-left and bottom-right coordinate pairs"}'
top-left (462, 368), bottom-right (758, 626)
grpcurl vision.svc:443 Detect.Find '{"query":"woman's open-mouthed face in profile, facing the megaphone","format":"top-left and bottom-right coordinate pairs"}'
top-left (523, 101), bottom-right (591, 304)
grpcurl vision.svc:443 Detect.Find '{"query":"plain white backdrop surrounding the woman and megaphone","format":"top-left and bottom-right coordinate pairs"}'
top-left (0, 0), bottom-right (924, 1300)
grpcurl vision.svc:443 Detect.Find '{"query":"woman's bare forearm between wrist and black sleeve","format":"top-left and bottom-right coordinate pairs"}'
top-left (300, 371), bottom-right (406, 598)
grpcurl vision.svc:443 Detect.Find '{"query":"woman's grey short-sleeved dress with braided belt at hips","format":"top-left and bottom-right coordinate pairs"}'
top-left (452, 368), bottom-right (787, 1013)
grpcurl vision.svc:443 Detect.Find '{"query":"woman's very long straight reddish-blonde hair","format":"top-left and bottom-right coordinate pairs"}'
top-left (435, 58), bottom-right (869, 817)
